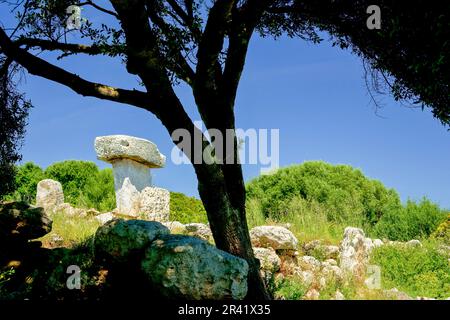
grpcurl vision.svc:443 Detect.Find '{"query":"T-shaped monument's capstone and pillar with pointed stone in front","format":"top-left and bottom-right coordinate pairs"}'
top-left (95, 135), bottom-right (166, 216)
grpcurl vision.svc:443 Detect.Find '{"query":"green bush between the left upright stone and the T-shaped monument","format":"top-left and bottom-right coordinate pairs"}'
top-left (45, 160), bottom-right (98, 205)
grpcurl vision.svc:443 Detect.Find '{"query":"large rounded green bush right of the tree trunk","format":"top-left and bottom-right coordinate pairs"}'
top-left (247, 162), bottom-right (401, 224)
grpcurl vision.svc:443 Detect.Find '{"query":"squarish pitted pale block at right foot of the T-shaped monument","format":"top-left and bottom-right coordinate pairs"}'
top-left (140, 187), bottom-right (170, 222)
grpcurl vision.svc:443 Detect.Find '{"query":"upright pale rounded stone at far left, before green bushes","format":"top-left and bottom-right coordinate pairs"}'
top-left (36, 179), bottom-right (64, 214)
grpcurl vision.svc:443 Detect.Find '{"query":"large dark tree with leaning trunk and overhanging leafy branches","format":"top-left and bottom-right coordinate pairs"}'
top-left (0, 0), bottom-right (450, 299)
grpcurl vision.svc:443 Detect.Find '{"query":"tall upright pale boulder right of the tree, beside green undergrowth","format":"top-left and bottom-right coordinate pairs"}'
top-left (340, 227), bottom-right (374, 277)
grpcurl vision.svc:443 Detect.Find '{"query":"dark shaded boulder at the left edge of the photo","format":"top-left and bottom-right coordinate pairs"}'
top-left (0, 202), bottom-right (52, 247)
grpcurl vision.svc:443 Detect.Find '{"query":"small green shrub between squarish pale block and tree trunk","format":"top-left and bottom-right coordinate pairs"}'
top-left (170, 192), bottom-right (208, 223)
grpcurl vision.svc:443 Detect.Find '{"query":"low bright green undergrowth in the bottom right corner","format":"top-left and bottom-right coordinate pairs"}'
top-left (371, 243), bottom-right (450, 299)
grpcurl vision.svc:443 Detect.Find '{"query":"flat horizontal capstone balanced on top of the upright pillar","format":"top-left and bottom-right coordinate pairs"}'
top-left (95, 135), bottom-right (166, 168)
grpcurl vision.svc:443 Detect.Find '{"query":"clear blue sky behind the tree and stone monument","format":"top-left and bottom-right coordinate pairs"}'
top-left (14, 32), bottom-right (450, 208)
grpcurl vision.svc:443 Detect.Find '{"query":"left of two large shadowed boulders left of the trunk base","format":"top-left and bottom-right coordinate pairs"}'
top-left (94, 219), bottom-right (169, 263)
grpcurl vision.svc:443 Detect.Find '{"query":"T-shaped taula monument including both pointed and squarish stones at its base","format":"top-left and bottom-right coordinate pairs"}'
top-left (95, 135), bottom-right (170, 222)
